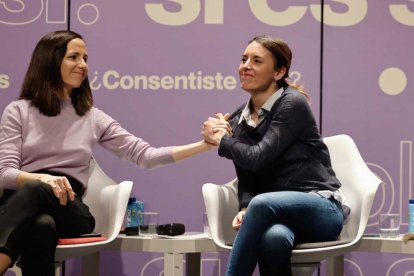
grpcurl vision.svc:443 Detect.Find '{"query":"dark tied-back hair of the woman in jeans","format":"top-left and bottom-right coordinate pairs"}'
top-left (249, 35), bottom-right (310, 101)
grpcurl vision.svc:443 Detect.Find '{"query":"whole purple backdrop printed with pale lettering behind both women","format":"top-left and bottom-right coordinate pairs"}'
top-left (0, 0), bottom-right (414, 276)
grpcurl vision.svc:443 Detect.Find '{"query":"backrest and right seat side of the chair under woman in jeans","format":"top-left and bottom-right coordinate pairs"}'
top-left (291, 134), bottom-right (382, 264)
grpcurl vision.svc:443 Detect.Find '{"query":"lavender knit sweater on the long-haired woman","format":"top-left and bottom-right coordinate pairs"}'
top-left (0, 100), bottom-right (174, 194)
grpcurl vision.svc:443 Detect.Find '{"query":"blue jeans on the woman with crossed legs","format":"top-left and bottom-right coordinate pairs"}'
top-left (226, 191), bottom-right (343, 276)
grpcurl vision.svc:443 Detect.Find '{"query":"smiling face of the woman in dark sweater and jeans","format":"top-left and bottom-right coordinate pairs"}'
top-left (239, 41), bottom-right (278, 93)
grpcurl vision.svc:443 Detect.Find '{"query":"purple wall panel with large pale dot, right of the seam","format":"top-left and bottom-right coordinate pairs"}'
top-left (322, 0), bottom-right (414, 275)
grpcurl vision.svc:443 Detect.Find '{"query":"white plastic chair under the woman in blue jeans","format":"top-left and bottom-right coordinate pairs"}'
top-left (202, 134), bottom-right (381, 276)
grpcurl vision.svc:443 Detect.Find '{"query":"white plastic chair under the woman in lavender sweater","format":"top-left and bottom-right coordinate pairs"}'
top-left (10, 159), bottom-right (132, 276)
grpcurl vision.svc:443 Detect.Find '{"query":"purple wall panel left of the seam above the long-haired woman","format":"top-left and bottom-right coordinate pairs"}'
top-left (0, 0), bottom-right (68, 111)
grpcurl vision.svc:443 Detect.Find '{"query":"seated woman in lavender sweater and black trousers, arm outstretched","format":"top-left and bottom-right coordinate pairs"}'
top-left (0, 31), bottom-right (215, 276)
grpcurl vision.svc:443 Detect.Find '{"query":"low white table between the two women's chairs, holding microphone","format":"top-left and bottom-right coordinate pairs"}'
top-left (105, 233), bottom-right (224, 276)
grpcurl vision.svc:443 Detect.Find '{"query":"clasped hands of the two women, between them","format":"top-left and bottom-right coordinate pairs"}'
top-left (201, 113), bottom-right (233, 146)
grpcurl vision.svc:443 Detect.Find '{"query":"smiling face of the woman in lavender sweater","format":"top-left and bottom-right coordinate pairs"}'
top-left (60, 38), bottom-right (88, 97)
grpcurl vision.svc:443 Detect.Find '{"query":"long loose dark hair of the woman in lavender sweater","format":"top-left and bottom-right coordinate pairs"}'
top-left (19, 31), bottom-right (93, 117)
